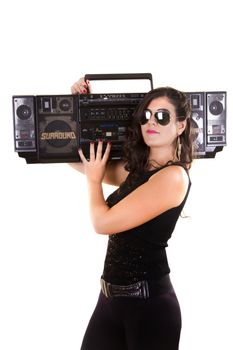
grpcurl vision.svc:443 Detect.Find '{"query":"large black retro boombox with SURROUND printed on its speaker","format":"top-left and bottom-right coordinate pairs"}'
top-left (13, 73), bottom-right (226, 163)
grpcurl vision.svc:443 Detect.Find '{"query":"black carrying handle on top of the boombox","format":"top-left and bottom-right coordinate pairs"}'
top-left (84, 73), bottom-right (153, 89)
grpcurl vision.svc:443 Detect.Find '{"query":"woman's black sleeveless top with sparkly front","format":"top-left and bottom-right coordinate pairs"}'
top-left (102, 167), bottom-right (191, 285)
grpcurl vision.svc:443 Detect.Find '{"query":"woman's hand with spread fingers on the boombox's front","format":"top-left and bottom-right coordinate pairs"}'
top-left (78, 141), bottom-right (111, 184)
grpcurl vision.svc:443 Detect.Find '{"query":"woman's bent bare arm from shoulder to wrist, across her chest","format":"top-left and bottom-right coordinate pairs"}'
top-left (88, 165), bottom-right (189, 235)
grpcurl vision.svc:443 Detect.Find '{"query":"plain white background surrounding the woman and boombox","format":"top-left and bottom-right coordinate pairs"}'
top-left (0, 0), bottom-right (233, 350)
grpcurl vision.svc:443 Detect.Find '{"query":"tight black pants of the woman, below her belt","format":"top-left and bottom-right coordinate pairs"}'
top-left (81, 278), bottom-right (181, 350)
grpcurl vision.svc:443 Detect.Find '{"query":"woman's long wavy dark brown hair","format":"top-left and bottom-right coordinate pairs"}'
top-left (124, 87), bottom-right (193, 185)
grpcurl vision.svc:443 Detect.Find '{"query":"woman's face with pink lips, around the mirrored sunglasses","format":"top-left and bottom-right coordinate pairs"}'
top-left (141, 97), bottom-right (185, 147)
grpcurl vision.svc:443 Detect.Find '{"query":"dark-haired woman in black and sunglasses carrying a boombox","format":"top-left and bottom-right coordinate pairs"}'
top-left (72, 79), bottom-right (192, 350)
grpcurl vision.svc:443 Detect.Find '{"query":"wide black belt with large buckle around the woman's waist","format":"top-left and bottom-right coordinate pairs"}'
top-left (100, 275), bottom-right (173, 299)
